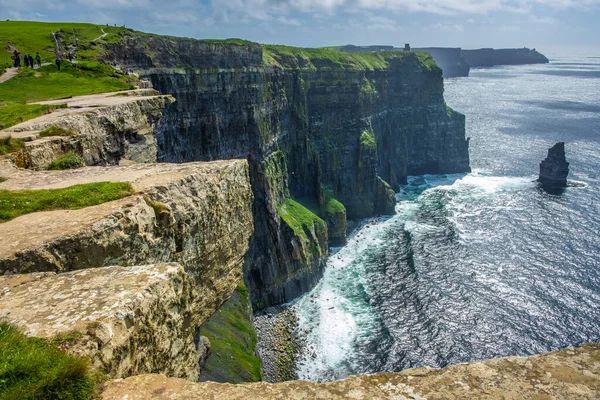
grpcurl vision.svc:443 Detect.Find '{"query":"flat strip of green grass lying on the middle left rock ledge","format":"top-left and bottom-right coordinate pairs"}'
top-left (0, 182), bottom-right (134, 222)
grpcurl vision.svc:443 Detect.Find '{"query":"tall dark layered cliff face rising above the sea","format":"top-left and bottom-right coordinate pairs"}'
top-left (107, 36), bottom-right (469, 308)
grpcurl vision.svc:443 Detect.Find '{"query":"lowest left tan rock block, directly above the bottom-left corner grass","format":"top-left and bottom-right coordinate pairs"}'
top-left (0, 264), bottom-right (201, 380)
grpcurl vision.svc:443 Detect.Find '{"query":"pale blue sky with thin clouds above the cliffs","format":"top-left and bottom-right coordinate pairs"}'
top-left (0, 0), bottom-right (600, 56)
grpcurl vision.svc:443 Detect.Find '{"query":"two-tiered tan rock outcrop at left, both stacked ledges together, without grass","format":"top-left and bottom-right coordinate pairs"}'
top-left (0, 160), bottom-right (253, 380)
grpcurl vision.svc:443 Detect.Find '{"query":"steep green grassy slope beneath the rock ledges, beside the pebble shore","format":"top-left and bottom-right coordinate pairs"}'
top-left (200, 282), bottom-right (262, 383)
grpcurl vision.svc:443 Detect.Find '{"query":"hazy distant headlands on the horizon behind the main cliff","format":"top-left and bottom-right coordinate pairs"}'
top-left (339, 45), bottom-right (549, 78)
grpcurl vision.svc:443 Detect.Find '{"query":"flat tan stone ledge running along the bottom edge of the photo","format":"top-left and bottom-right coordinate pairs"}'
top-left (102, 344), bottom-right (600, 400)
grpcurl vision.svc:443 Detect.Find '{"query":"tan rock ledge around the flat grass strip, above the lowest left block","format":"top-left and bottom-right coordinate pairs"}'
top-left (0, 160), bottom-right (253, 332)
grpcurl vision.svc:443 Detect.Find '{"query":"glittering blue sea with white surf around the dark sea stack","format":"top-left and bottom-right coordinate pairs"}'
top-left (295, 57), bottom-right (600, 380)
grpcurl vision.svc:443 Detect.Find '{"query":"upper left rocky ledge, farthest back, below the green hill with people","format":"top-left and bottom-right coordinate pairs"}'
top-left (0, 89), bottom-right (175, 169)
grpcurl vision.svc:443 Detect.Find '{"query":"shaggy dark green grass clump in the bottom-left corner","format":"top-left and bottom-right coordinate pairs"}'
top-left (0, 322), bottom-right (96, 400)
